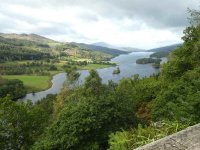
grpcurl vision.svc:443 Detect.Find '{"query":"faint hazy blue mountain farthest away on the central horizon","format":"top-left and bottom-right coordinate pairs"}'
top-left (92, 42), bottom-right (144, 52)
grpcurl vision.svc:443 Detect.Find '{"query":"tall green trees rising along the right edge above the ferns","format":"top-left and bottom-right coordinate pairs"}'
top-left (151, 11), bottom-right (200, 124)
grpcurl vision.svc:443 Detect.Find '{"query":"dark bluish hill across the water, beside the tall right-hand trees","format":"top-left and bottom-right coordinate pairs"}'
top-left (148, 44), bottom-right (182, 58)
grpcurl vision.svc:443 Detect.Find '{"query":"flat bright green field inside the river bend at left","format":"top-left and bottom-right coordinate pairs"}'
top-left (2, 75), bottom-right (51, 93)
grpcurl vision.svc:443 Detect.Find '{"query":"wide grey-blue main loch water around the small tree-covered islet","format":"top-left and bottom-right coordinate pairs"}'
top-left (79, 52), bottom-right (159, 83)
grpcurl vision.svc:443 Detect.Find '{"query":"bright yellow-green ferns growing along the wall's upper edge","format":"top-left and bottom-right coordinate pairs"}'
top-left (109, 121), bottom-right (188, 150)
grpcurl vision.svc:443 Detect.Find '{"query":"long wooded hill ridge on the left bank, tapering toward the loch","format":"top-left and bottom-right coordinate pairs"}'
top-left (0, 33), bottom-right (128, 60)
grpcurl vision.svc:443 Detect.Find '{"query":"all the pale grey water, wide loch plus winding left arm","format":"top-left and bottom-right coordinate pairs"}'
top-left (23, 52), bottom-right (165, 103)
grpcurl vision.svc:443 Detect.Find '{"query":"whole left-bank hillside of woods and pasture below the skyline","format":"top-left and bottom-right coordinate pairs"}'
top-left (0, 34), bottom-right (119, 62)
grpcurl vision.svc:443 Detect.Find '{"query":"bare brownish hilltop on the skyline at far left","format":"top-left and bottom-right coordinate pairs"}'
top-left (0, 33), bottom-right (56, 43)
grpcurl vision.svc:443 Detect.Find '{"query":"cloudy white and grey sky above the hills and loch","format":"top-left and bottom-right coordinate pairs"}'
top-left (0, 0), bottom-right (200, 49)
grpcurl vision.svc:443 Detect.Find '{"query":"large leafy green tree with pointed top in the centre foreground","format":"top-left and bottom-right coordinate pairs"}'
top-left (33, 70), bottom-right (137, 150)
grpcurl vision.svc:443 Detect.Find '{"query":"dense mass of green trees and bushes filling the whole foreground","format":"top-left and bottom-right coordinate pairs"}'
top-left (0, 11), bottom-right (200, 150)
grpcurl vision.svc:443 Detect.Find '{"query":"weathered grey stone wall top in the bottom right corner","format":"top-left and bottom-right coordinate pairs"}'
top-left (135, 124), bottom-right (200, 150)
